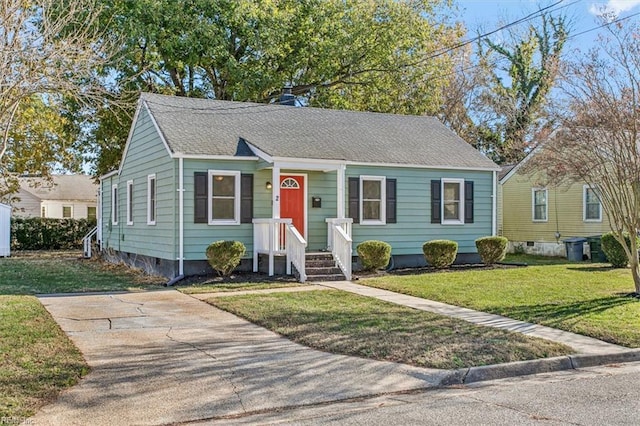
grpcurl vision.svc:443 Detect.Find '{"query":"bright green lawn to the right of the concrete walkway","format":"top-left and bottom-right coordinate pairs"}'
top-left (359, 257), bottom-right (640, 348)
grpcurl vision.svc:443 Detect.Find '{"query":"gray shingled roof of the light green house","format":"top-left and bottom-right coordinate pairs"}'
top-left (141, 93), bottom-right (497, 169)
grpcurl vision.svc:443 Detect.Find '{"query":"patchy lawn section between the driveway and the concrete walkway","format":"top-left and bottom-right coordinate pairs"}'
top-left (208, 290), bottom-right (571, 368)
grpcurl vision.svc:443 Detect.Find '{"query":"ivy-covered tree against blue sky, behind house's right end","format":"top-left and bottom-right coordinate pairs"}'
top-left (474, 12), bottom-right (569, 164)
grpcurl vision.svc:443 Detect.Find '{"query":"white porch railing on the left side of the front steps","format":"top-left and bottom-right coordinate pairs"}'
top-left (253, 219), bottom-right (307, 282)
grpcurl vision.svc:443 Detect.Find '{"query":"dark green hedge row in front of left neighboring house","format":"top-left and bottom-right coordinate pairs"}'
top-left (11, 217), bottom-right (96, 250)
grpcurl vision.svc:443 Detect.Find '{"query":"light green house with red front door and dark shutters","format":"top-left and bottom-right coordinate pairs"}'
top-left (98, 93), bottom-right (499, 281)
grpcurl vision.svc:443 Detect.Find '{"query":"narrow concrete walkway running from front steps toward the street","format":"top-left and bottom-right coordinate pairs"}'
top-left (317, 281), bottom-right (631, 355)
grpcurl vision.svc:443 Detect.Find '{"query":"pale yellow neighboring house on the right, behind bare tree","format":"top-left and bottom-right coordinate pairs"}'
top-left (498, 156), bottom-right (611, 256)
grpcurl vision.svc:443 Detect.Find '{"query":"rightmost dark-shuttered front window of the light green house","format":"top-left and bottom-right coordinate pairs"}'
top-left (431, 178), bottom-right (474, 225)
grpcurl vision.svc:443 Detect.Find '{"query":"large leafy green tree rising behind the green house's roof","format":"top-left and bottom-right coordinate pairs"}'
top-left (92, 0), bottom-right (462, 173)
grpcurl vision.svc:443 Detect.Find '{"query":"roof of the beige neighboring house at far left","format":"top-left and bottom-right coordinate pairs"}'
top-left (19, 175), bottom-right (98, 201)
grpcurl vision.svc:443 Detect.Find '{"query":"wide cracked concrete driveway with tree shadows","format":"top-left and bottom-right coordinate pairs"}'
top-left (30, 290), bottom-right (448, 425)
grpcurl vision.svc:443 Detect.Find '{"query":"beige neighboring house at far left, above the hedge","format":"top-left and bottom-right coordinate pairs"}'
top-left (10, 175), bottom-right (98, 220)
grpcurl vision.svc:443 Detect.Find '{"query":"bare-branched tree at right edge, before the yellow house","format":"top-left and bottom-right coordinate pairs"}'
top-left (533, 18), bottom-right (640, 293)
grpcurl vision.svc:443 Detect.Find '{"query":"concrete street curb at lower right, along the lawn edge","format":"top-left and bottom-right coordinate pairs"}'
top-left (439, 349), bottom-right (640, 386)
